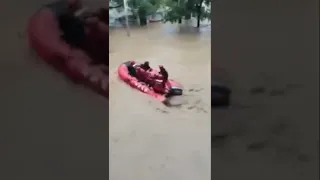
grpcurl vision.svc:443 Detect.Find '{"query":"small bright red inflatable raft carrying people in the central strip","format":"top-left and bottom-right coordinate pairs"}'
top-left (118, 61), bottom-right (183, 103)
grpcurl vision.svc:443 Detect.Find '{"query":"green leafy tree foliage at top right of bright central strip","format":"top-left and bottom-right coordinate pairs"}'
top-left (164, 0), bottom-right (211, 27)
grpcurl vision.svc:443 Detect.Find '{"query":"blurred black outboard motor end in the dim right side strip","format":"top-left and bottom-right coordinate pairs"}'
top-left (211, 84), bottom-right (231, 108)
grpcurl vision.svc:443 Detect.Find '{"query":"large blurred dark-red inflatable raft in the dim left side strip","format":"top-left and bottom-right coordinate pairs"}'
top-left (27, 1), bottom-right (109, 97)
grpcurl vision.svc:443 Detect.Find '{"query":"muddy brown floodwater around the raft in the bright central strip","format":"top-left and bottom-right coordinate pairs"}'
top-left (109, 23), bottom-right (211, 180)
